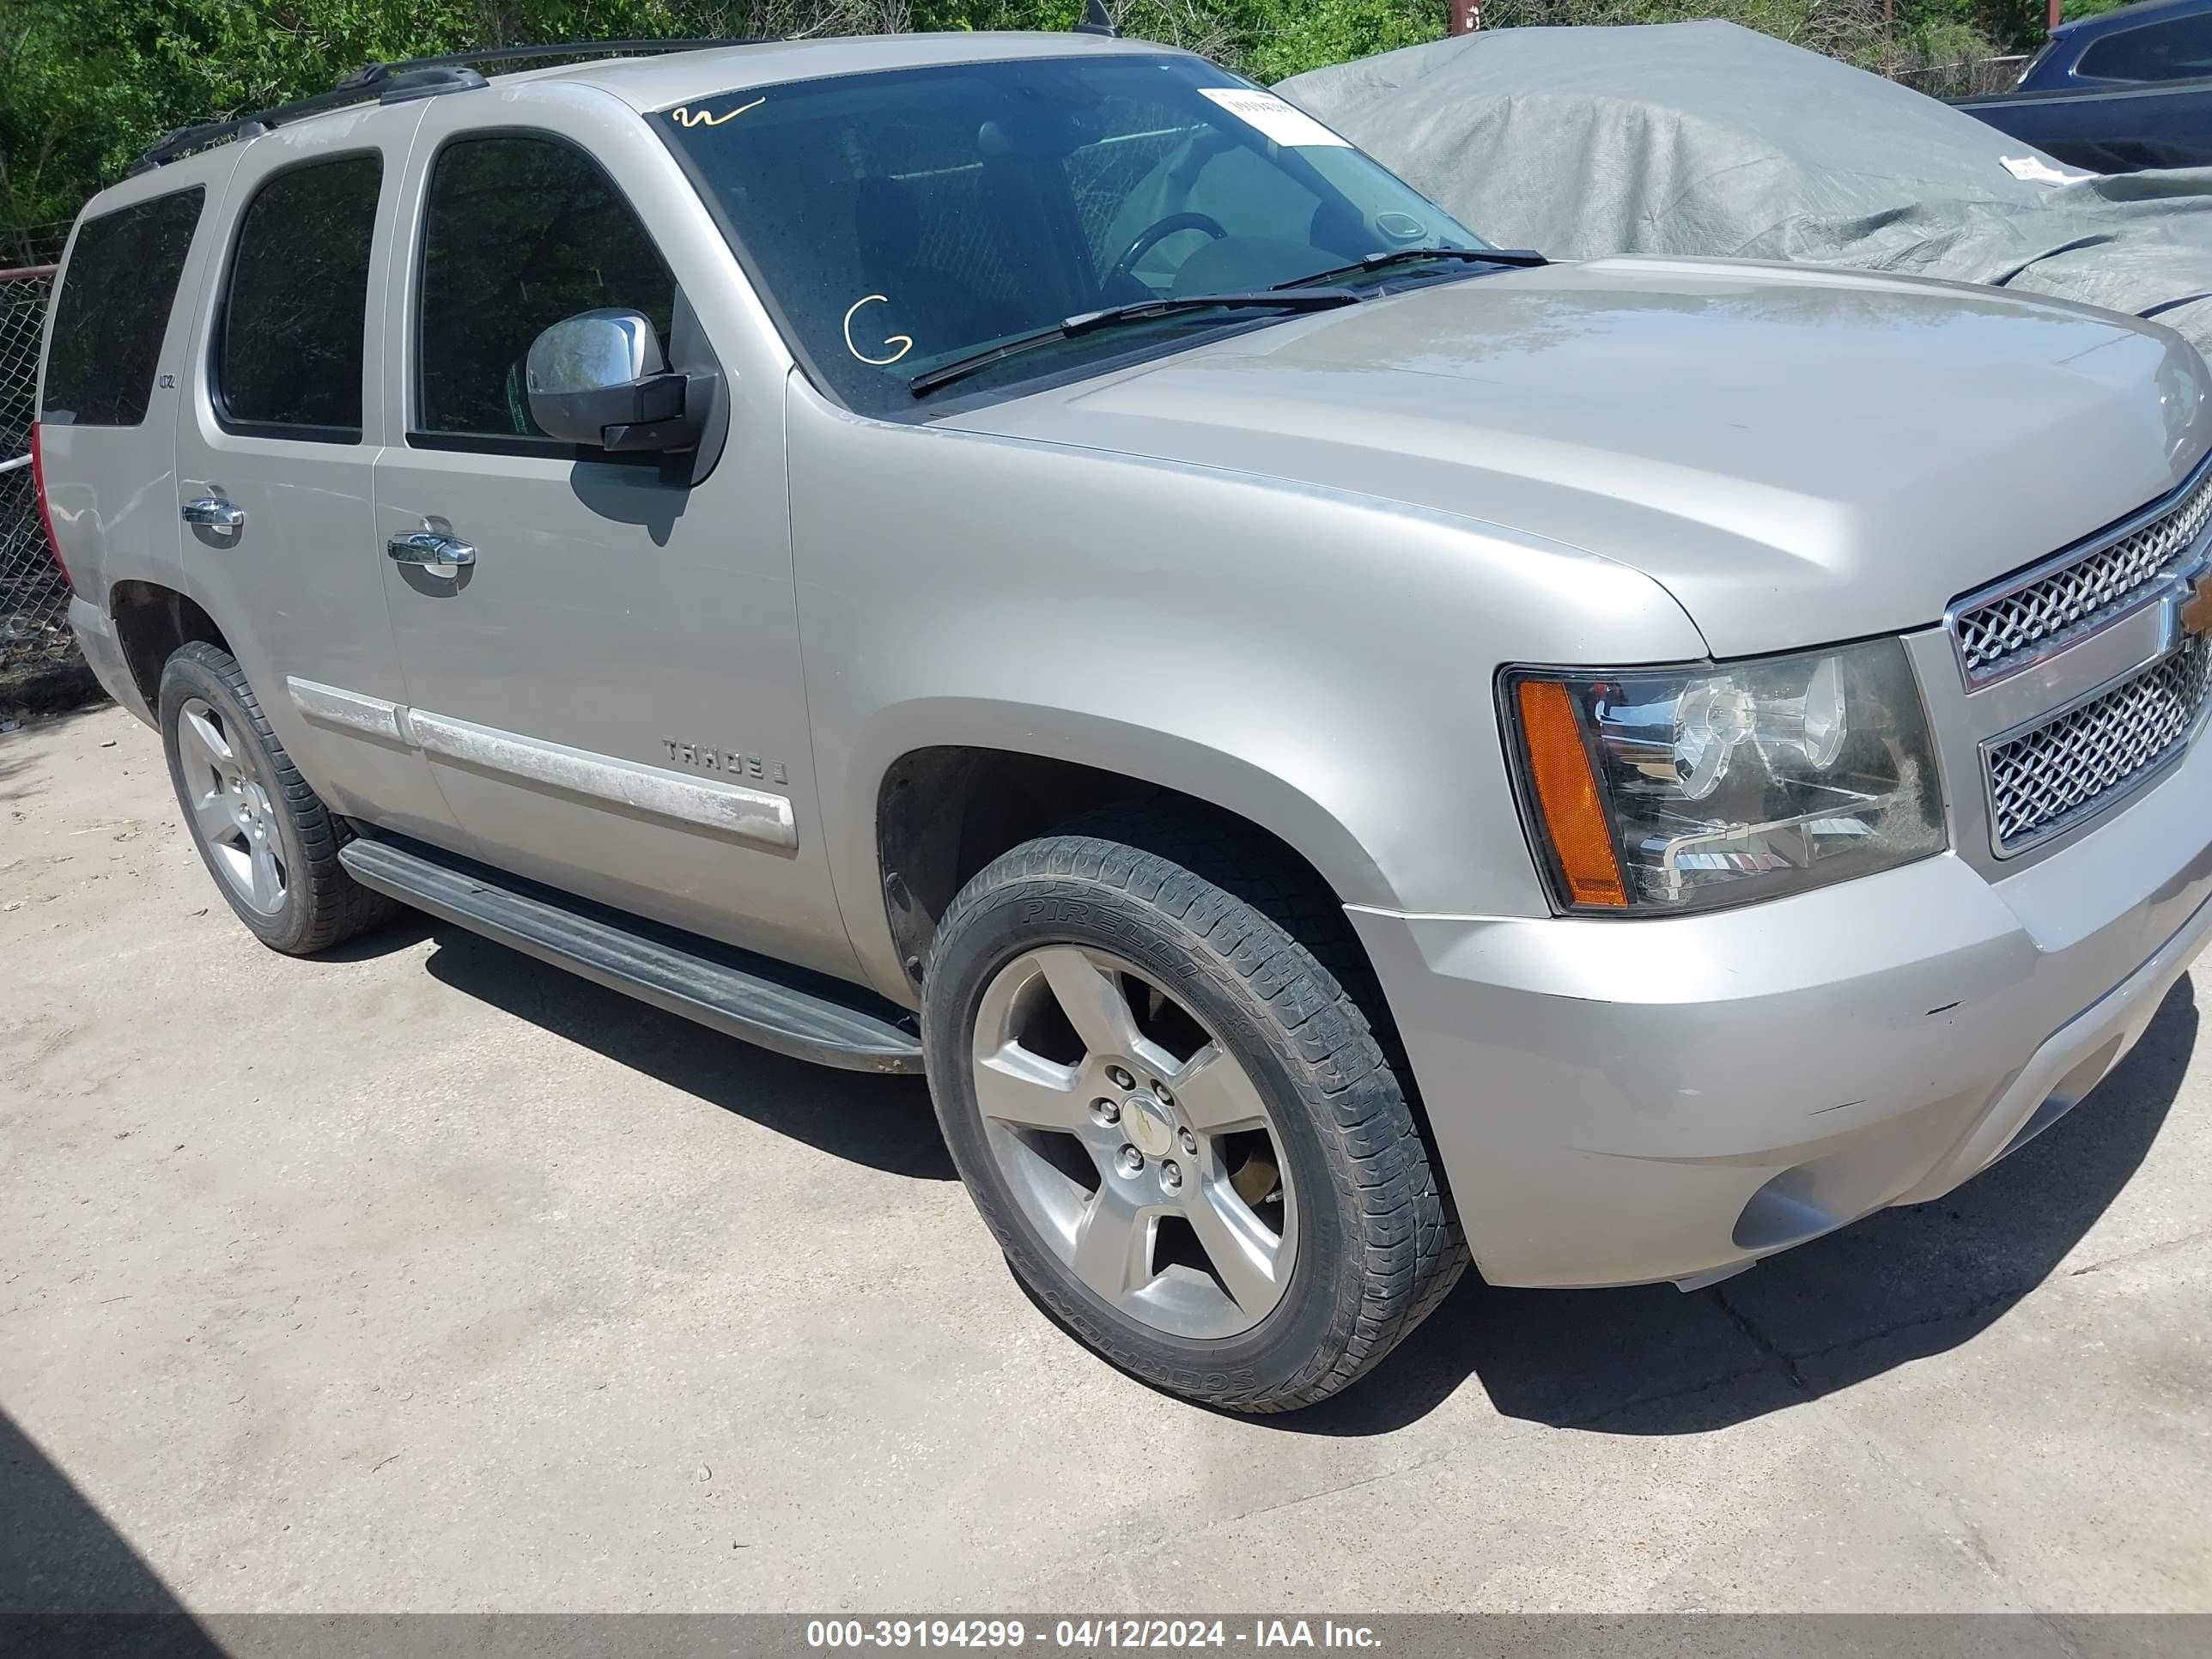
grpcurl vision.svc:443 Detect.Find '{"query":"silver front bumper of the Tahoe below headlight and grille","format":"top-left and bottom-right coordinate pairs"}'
top-left (1352, 725), bottom-right (2212, 1285)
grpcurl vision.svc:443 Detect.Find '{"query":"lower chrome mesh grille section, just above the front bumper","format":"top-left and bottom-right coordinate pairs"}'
top-left (1984, 635), bottom-right (2212, 854)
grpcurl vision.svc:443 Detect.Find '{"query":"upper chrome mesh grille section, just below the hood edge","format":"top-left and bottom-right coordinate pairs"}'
top-left (1951, 467), bottom-right (2212, 686)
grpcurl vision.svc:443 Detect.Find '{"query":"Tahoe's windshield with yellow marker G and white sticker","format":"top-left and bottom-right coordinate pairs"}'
top-left (654, 53), bottom-right (1484, 418)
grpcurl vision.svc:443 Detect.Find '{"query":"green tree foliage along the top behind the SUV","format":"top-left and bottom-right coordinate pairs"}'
top-left (0, 0), bottom-right (2070, 243)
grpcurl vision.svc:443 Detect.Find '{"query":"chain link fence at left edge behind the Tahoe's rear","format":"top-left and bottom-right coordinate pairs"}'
top-left (0, 265), bottom-right (91, 719)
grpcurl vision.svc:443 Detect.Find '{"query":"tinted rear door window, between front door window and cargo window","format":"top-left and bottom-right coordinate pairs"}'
top-left (215, 155), bottom-right (385, 441)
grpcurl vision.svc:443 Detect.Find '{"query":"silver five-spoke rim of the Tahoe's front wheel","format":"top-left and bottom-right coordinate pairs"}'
top-left (971, 945), bottom-right (1298, 1340)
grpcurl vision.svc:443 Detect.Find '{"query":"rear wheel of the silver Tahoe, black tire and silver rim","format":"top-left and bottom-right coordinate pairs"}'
top-left (157, 641), bottom-right (398, 956)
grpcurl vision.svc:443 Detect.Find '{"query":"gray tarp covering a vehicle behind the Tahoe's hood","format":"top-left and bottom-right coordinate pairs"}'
top-left (1276, 22), bottom-right (2212, 356)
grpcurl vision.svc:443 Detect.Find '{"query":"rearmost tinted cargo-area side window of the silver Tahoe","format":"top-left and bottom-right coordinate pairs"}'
top-left (38, 184), bottom-right (208, 427)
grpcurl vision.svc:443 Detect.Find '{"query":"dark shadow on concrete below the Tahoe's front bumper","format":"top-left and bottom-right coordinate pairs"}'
top-left (1274, 978), bottom-right (2197, 1436)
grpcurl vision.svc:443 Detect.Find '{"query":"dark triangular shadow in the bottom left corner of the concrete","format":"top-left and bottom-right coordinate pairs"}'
top-left (0, 1411), bottom-right (222, 1659)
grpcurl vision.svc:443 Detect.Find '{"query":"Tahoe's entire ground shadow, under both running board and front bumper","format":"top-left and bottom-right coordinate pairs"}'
top-left (349, 914), bottom-right (2197, 1436)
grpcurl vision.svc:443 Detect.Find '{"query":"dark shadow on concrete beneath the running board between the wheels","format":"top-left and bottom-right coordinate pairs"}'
top-left (411, 914), bottom-right (953, 1182)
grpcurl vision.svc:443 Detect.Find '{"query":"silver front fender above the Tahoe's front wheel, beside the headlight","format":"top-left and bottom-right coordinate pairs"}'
top-left (787, 376), bottom-right (1704, 994)
